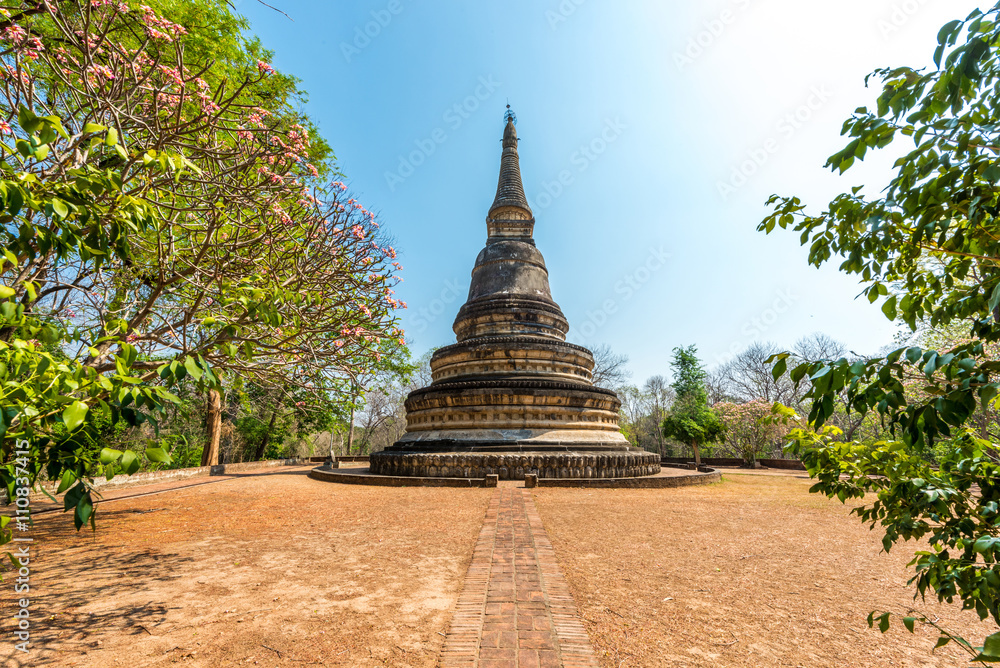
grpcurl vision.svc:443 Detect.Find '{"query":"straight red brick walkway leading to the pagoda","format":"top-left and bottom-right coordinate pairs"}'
top-left (441, 487), bottom-right (598, 668)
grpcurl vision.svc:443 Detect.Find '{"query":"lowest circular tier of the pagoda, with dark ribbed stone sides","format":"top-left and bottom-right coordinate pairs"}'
top-left (369, 443), bottom-right (660, 480)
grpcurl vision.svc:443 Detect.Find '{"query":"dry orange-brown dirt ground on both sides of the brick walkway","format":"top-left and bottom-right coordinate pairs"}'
top-left (9, 468), bottom-right (995, 668)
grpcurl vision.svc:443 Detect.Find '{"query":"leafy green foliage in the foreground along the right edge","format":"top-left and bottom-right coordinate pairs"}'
top-left (759, 5), bottom-right (1000, 662)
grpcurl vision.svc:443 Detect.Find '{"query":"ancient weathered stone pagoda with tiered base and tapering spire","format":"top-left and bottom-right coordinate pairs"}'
top-left (371, 106), bottom-right (660, 479)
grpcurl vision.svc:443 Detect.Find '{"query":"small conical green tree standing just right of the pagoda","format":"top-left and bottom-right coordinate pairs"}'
top-left (661, 345), bottom-right (723, 467)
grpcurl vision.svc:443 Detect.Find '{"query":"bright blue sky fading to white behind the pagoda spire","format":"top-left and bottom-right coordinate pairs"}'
top-left (237, 0), bottom-right (978, 383)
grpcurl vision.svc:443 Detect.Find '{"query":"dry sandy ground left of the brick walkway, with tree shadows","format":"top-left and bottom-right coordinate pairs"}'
top-left (0, 469), bottom-right (491, 668)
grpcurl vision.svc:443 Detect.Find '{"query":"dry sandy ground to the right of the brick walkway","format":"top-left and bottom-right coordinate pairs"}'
top-left (534, 473), bottom-right (997, 668)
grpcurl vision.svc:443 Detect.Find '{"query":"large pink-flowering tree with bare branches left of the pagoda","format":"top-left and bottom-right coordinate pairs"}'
top-left (0, 0), bottom-right (405, 527)
